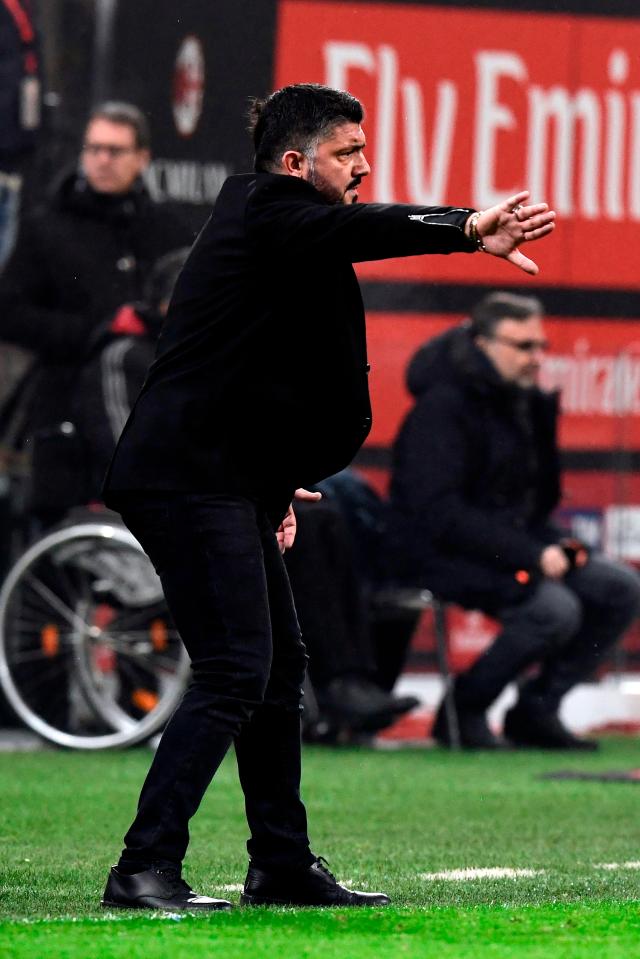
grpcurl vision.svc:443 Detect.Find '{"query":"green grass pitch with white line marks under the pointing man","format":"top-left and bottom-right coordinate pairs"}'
top-left (0, 739), bottom-right (640, 959)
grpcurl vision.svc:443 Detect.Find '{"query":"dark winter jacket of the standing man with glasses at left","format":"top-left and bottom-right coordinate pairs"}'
top-left (0, 173), bottom-right (193, 509)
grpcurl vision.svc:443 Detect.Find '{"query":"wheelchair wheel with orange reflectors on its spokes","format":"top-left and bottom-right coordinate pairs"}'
top-left (0, 520), bottom-right (189, 749)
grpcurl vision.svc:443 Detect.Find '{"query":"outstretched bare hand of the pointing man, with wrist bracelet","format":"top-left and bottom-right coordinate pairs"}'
top-left (465, 190), bottom-right (556, 276)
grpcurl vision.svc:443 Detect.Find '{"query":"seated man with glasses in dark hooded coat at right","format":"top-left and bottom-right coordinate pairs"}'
top-left (392, 293), bottom-right (640, 748)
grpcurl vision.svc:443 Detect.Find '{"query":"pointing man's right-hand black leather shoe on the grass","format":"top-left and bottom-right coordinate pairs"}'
top-left (240, 858), bottom-right (391, 906)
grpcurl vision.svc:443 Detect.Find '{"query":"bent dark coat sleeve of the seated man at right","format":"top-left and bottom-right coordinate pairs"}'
top-left (400, 390), bottom-right (545, 570)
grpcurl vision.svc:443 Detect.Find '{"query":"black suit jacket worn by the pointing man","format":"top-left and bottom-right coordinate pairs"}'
top-left (105, 173), bottom-right (474, 512)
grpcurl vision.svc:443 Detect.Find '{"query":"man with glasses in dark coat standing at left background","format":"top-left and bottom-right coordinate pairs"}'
top-left (0, 102), bottom-right (193, 525)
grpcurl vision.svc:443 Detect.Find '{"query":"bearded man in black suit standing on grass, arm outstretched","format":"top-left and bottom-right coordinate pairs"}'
top-left (103, 84), bottom-right (554, 909)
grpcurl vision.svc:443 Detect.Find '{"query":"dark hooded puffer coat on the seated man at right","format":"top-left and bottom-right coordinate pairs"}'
top-left (391, 326), bottom-right (560, 611)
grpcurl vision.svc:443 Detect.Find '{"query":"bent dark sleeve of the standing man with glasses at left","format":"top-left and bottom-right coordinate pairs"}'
top-left (0, 221), bottom-right (94, 360)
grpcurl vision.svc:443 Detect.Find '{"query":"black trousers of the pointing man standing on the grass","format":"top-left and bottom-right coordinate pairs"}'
top-left (120, 493), bottom-right (313, 868)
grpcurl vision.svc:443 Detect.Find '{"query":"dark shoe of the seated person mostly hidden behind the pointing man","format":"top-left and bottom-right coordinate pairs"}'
top-left (316, 676), bottom-right (420, 732)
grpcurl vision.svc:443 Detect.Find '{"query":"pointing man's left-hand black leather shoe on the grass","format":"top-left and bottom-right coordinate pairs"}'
top-left (101, 863), bottom-right (231, 912)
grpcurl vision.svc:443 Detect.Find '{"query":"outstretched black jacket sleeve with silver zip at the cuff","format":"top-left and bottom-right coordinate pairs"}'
top-left (247, 176), bottom-right (475, 263)
